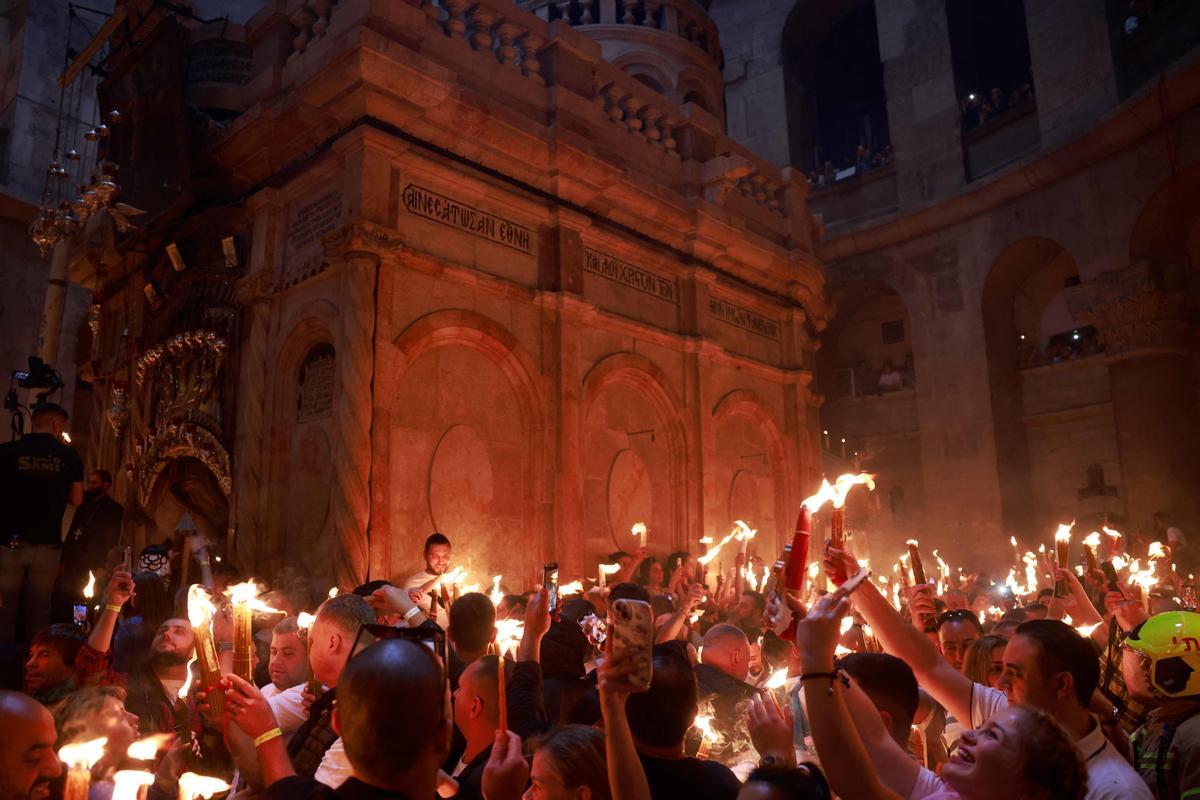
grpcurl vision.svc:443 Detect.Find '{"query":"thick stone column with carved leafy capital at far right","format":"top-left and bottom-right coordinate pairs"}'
top-left (1068, 261), bottom-right (1200, 533)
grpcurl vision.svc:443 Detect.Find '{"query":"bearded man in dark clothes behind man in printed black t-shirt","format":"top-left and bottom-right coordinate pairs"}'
top-left (54, 469), bottom-right (125, 621)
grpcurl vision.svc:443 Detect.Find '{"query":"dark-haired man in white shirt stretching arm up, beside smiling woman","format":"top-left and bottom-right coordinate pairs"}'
top-left (830, 552), bottom-right (1152, 800)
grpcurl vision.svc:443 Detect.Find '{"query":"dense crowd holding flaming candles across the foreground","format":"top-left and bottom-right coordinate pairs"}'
top-left (0, 413), bottom-right (1200, 800)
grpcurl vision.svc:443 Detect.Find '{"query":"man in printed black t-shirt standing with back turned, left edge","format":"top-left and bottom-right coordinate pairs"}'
top-left (0, 403), bottom-right (83, 642)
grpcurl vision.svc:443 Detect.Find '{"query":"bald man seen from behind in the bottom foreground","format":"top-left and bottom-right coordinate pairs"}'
top-left (265, 639), bottom-right (452, 800)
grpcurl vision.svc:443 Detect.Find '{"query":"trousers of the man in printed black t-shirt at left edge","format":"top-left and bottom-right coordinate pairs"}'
top-left (0, 542), bottom-right (62, 643)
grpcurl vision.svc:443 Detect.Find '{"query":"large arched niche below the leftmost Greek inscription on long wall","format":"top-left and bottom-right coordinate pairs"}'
top-left (384, 309), bottom-right (545, 578)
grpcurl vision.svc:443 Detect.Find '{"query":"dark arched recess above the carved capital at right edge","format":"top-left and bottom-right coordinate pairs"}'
top-left (1129, 166), bottom-right (1200, 269)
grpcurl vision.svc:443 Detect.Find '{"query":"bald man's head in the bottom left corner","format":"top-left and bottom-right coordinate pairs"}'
top-left (0, 691), bottom-right (62, 800)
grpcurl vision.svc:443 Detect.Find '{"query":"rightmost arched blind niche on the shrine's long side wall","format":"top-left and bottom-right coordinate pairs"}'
top-left (713, 389), bottom-right (798, 560)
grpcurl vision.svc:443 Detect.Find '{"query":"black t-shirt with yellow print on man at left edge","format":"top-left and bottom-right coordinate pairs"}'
top-left (0, 433), bottom-right (83, 545)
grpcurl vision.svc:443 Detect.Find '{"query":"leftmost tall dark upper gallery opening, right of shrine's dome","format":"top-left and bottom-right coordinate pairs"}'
top-left (782, 0), bottom-right (890, 172)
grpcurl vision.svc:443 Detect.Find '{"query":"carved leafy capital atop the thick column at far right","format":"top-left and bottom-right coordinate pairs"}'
top-left (1067, 260), bottom-right (1188, 359)
